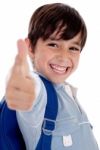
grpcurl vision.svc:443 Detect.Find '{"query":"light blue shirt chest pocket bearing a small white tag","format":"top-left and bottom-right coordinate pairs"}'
top-left (51, 117), bottom-right (82, 150)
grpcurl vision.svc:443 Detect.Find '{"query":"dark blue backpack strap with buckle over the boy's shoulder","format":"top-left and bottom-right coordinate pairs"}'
top-left (36, 76), bottom-right (58, 150)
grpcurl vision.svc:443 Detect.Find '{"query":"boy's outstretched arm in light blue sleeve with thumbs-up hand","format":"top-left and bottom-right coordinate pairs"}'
top-left (5, 40), bottom-right (47, 149)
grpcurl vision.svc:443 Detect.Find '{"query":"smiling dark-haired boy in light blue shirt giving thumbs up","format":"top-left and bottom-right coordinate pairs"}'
top-left (1, 3), bottom-right (98, 150)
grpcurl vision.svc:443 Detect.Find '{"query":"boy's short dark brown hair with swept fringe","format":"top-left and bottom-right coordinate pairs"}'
top-left (28, 3), bottom-right (87, 48)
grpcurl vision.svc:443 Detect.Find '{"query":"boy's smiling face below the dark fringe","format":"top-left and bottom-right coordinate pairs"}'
top-left (28, 34), bottom-right (81, 83)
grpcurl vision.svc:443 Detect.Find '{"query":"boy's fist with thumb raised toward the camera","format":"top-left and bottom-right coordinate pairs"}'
top-left (5, 40), bottom-right (35, 111)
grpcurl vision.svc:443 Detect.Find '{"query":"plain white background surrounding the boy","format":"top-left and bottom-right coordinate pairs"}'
top-left (0, 0), bottom-right (100, 145)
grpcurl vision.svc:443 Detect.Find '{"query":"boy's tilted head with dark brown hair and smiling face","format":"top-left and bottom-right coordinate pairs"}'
top-left (27, 3), bottom-right (87, 83)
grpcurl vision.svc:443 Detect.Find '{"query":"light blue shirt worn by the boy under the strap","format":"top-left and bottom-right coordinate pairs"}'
top-left (17, 75), bottom-right (99, 150)
